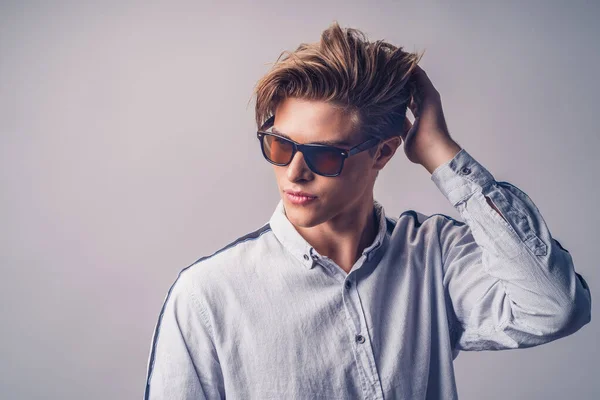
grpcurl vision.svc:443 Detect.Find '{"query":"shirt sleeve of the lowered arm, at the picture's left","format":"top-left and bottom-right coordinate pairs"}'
top-left (144, 270), bottom-right (225, 400)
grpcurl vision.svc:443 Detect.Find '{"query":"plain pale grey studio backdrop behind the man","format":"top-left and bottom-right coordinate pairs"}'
top-left (0, 0), bottom-right (600, 400)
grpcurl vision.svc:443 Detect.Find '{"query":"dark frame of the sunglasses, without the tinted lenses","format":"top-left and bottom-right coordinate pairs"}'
top-left (256, 116), bottom-right (381, 177)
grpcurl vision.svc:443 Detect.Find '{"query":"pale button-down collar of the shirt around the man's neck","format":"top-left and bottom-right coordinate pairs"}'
top-left (269, 199), bottom-right (387, 269)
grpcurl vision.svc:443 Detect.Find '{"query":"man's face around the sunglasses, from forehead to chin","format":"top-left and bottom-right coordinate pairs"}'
top-left (273, 98), bottom-right (378, 228)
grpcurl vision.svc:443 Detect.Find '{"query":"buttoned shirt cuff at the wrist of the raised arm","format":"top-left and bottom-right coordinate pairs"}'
top-left (431, 149), bottom-right (494, 207)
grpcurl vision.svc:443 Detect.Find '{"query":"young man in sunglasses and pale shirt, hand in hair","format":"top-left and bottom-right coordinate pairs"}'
top-left (145, 24), bottom-right (591, 399)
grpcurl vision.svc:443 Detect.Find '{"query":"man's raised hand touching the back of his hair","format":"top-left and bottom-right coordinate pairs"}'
top-left (401, 65), bottom-right (461, 173)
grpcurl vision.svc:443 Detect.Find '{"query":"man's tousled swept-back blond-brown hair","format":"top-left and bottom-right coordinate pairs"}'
top-left (255, 22), bottom-right (424, 156)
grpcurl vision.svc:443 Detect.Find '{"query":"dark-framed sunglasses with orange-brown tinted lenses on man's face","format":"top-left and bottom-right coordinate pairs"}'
top-left (256, 116), bottom-right (379, 177)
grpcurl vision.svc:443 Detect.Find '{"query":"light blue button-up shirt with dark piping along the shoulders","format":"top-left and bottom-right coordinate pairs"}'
top-left (145, 149), bottom-right (591, 400)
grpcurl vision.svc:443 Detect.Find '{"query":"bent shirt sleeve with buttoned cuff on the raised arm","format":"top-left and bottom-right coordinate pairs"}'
top-left (431, 149), bottom-right (591, 351)
